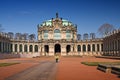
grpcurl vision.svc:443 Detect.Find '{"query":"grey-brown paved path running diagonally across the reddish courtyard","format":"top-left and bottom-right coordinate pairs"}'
top-left (5, 61), bottom-right (57, 80)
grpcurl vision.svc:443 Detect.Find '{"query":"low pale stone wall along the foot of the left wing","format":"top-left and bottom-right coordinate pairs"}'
top-left (0, 53), bottom-right (40, 59)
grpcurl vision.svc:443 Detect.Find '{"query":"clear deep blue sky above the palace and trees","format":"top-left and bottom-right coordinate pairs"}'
top-left (0, 0), bottom-right (120, 37)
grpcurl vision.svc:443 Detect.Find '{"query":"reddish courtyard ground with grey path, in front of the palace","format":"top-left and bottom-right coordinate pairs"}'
top-left (0, 57), bottom-right (120, 80)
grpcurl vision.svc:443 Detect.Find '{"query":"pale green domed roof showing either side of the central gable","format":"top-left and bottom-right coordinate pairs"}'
top-left (42, 19), bottom-right (72, 26)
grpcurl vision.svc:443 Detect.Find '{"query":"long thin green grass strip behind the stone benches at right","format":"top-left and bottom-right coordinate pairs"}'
top-left (81, 62), bottom-right (120, 66)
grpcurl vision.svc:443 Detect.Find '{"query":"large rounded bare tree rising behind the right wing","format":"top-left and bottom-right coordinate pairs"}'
top-left (98, 23), bottom-right (114, 37)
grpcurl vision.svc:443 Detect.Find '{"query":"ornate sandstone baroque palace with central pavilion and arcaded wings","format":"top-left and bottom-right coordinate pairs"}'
top-left (0, 13), bottom-right (120, 57)
